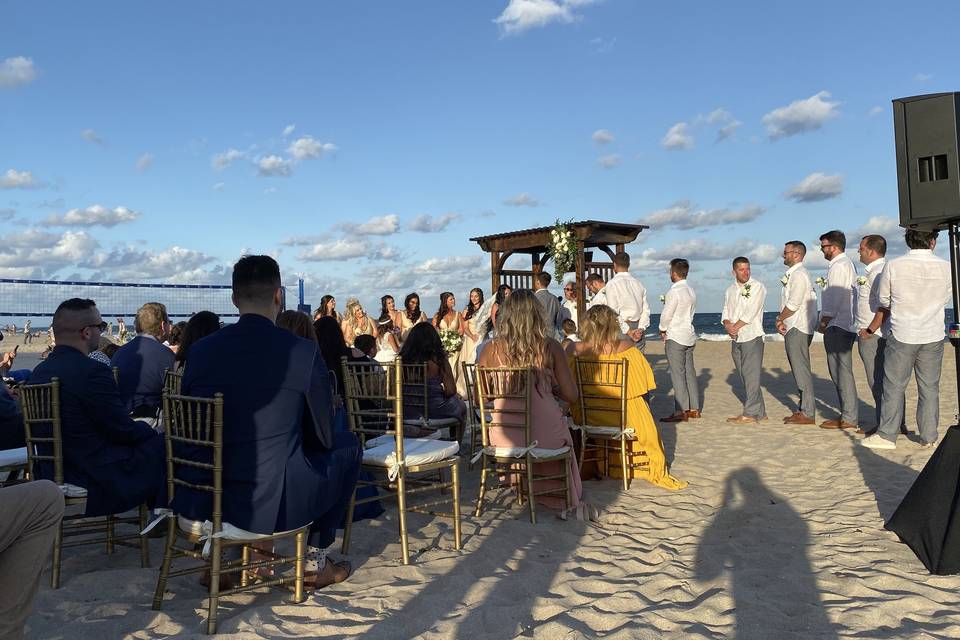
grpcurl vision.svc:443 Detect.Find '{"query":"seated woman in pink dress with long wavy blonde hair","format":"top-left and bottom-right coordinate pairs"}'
top-left (477, 289), bottom-right (583, 513)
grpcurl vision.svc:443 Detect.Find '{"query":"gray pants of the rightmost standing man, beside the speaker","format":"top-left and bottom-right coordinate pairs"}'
top-left (877, 336), bottom-right (943, 442)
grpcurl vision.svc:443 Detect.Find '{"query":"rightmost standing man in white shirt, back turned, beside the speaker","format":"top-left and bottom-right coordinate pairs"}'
top-left (861, 229), bottom-right (952, 449)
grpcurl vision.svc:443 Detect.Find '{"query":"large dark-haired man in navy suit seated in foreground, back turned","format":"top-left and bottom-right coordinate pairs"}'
top-left (171, 256), bottom-right (362, 587)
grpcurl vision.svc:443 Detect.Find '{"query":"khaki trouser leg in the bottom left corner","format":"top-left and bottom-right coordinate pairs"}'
top-left (0, 480), bottom-right (63, 640)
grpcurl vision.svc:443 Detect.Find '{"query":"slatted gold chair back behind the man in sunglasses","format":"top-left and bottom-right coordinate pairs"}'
top-left (18, 378), bottom-right (63, 485)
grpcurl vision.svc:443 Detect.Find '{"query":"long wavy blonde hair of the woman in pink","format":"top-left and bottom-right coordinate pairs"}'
top-left (497, 289), bottom-right (546, 369)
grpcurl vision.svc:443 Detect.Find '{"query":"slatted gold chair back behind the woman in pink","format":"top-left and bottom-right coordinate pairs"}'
top-left (476, 366), bottom-right (533, 447)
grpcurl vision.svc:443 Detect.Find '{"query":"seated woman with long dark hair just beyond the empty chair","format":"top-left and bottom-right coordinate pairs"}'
top-left (400, 322), bottom-right (467, 441)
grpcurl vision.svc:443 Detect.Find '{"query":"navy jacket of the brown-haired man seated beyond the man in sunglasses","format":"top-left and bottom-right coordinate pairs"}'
top-left (110, 336), bottom-right (174, 412)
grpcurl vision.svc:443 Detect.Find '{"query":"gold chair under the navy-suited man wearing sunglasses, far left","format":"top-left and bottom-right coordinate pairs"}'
top-left (19, 378), bottom-right (150, 589)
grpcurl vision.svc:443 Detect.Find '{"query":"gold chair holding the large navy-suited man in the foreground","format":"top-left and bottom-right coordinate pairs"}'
top-left (151, 392), bottom-right (310, 634)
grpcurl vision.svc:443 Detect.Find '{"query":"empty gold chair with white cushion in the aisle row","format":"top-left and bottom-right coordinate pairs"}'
top-left (342, 358), bottom-right (461, 564)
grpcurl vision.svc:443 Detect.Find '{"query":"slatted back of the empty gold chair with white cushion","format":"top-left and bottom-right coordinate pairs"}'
top-left (340, 358), bottom-right (405, 460)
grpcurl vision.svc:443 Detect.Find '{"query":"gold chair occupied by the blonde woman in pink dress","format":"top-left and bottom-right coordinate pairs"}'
top-left (476, 367), bottom-right (573, 524)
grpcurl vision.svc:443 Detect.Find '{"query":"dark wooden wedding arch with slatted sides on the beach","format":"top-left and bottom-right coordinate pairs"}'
top-left (470, 220), bottom-right (650, 317)
